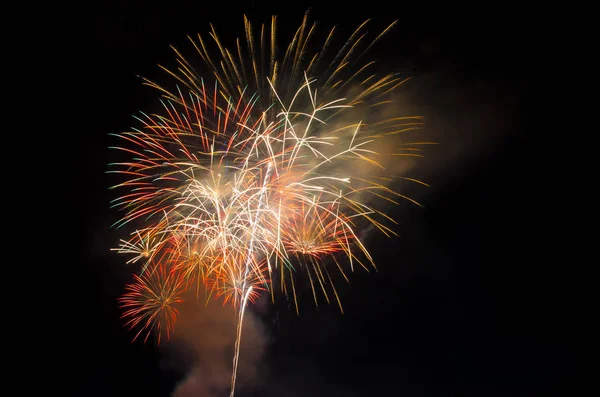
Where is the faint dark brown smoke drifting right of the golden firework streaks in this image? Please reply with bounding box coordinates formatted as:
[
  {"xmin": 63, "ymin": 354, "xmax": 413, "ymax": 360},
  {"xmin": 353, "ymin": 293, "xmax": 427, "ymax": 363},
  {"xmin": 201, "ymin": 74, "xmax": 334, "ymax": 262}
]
[{"xmin": 396, "ymin": 70, "xmax": 518, "ymax": 187}]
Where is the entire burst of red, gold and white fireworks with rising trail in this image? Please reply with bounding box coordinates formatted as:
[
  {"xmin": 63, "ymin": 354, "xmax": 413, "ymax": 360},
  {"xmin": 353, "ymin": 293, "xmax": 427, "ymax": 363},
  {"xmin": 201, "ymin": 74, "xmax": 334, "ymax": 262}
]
[{"xmin": 109, "ymin": 15, "xmax": 429, "ymax": 397}]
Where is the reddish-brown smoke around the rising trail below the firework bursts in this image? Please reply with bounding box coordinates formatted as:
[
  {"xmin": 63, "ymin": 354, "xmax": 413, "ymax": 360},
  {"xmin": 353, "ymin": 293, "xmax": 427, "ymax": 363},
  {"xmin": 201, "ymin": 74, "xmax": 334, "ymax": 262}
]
[{"xmin": 164, "ymin": 289, "xmax": 268, "ymax": 397}]
